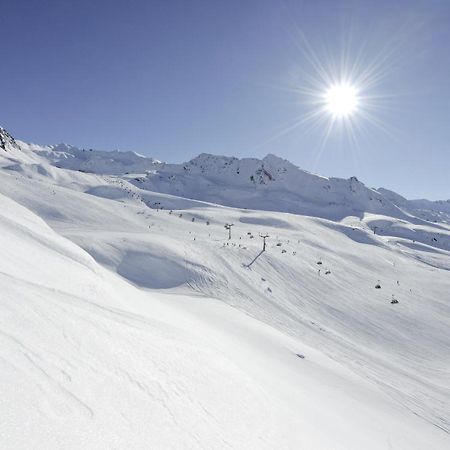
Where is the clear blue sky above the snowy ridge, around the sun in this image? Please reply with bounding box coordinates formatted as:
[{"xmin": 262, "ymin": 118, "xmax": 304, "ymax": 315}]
[{"xmin": 0, "ymin": 0, "xmax": 450, "ymax": 199}]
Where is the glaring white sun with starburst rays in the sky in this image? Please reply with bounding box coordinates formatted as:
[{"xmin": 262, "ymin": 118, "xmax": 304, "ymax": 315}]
[{"xmin": 270, "ymin": 31, "xmax": 396, "ymax": 149}]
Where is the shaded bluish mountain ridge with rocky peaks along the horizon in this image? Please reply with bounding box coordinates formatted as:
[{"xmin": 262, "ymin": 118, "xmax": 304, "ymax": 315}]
[{"xmin": 10, "ymin": 127, "xmax": 450, "ymax": 224}]
